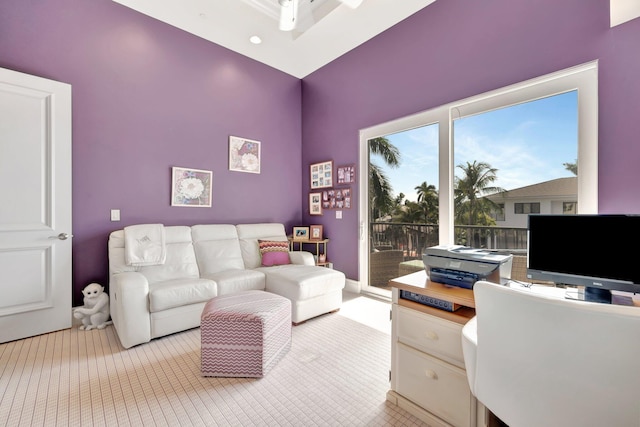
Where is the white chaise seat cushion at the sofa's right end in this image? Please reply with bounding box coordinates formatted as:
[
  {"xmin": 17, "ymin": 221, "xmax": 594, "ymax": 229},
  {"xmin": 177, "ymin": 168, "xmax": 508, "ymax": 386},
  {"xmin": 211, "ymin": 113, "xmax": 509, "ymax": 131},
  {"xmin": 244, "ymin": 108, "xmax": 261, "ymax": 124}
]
[{"xmin": 256, "ymin": 264, "xmax": 346, "ymax": 301}]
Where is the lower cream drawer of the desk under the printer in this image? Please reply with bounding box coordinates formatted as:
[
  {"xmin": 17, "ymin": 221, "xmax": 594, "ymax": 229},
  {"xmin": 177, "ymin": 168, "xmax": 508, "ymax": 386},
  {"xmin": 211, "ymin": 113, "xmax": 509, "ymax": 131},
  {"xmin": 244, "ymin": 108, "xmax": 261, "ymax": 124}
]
[{"xmin": 396, "ymin": 343, "xmax": 475, "ymax": 427}]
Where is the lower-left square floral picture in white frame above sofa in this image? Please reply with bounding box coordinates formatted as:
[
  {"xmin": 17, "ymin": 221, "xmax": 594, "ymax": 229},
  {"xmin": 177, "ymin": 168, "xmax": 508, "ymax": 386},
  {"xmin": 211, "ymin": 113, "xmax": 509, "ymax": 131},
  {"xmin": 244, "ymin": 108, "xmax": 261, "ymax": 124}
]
[{"xmin": 171, "ymin": 166, "xmax": 213, "ymax": 208}]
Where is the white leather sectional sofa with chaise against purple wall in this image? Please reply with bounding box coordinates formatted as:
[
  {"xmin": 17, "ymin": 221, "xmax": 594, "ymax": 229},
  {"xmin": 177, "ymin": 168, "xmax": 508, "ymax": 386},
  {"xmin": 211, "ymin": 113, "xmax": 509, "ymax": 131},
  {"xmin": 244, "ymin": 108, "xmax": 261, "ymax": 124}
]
[{"xmin": 108, "ymin": 223, "xmax": 346, "ymax": 348}]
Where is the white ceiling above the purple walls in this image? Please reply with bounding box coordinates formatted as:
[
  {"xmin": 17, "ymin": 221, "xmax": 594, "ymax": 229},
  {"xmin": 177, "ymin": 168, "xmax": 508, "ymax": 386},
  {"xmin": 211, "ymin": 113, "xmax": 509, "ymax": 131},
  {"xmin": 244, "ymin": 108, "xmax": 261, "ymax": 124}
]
[{"xmin": 113, "ymin": 0, "xmax": 435, "ymax": 78}]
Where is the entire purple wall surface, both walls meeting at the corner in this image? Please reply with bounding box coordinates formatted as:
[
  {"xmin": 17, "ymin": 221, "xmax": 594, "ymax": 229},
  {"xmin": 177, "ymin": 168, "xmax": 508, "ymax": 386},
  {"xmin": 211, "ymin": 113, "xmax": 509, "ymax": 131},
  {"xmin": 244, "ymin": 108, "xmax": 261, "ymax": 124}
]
[{"xmin": 0, "ymin": 0, "xmax": 640, "ymax": 305}]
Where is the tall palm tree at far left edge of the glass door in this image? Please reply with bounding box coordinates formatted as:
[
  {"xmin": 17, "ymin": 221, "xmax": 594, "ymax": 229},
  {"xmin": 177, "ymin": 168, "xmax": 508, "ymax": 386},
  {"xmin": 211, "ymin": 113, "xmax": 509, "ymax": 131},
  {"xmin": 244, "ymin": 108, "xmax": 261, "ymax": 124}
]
[{"xmin": 369, "ymin": 137, "xmax": 400, "ymax": 219}]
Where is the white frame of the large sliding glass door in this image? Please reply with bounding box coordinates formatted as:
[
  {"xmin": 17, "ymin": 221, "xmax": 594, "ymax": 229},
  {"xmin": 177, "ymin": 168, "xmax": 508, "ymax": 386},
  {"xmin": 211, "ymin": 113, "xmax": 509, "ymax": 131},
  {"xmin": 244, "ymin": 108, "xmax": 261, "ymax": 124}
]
[{"xmin": 359, "ymin": 61, "xmax": 598, "ymax": 288}]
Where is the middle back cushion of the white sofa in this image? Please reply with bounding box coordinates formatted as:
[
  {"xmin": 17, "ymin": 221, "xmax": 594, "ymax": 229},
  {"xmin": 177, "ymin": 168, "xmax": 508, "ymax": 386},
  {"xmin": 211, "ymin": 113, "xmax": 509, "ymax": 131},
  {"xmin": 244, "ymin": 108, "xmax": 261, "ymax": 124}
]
[{"xmin": 191, "ymin": 224, "xmax": 244, "ymax": 277}]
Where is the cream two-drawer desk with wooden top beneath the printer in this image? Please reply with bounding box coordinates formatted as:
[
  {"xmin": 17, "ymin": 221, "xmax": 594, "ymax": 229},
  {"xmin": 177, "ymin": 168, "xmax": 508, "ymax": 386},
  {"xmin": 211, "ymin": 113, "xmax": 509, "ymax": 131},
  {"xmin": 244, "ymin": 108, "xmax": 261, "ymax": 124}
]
[{"xmin": 387, "ymin": 270, "xmax": 488, "ymax": 427}]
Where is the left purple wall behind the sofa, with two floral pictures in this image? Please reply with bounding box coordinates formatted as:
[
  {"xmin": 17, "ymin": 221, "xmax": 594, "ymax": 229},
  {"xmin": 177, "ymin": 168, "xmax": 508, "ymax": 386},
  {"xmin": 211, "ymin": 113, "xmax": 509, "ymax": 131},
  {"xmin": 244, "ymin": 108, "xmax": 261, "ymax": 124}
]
[{"xmin": 0, "ymin": 0, "xmax": 302, "ymax": 305}]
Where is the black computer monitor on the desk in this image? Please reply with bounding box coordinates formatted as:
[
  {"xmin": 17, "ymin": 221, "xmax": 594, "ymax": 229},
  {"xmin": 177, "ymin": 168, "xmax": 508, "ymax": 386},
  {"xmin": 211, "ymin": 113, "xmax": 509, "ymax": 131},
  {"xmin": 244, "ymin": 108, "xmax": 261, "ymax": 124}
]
[{"xmin": 527, "ymin": 214, "xmax": 640, "ymax": 302}]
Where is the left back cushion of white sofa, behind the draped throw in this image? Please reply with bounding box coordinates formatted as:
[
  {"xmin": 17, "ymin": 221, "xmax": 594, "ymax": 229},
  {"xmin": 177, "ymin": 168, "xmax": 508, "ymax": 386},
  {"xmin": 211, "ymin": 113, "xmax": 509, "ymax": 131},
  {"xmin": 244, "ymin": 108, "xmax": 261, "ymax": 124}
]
[{"xmin": 109, "ymin": 226, "xmax": 200, "ymax": 283}]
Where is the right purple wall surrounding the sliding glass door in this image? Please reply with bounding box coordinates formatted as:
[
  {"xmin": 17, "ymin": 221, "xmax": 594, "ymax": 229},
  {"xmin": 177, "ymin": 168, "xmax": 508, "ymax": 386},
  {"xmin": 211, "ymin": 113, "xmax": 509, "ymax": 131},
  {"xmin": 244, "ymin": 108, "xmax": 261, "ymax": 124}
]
[{"xmin": 302, "ymin": 0, "xmax": 640, "ymax": 279}]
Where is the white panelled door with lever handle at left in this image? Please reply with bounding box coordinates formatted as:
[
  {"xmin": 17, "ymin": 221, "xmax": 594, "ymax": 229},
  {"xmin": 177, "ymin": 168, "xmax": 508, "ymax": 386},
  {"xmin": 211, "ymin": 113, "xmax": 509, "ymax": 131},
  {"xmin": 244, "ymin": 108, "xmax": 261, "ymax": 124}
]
[{"xmin": 0, "ymin": 68, "xmax": 72, "ymax": 342}]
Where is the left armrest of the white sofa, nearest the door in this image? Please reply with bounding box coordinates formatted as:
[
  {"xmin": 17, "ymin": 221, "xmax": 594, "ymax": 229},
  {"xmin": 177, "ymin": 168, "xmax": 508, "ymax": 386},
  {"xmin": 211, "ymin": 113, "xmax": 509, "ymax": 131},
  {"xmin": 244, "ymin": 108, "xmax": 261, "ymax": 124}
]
[{"xmin": 109, "ymin": 272, "xmax": 151, "ymax": 348}]
